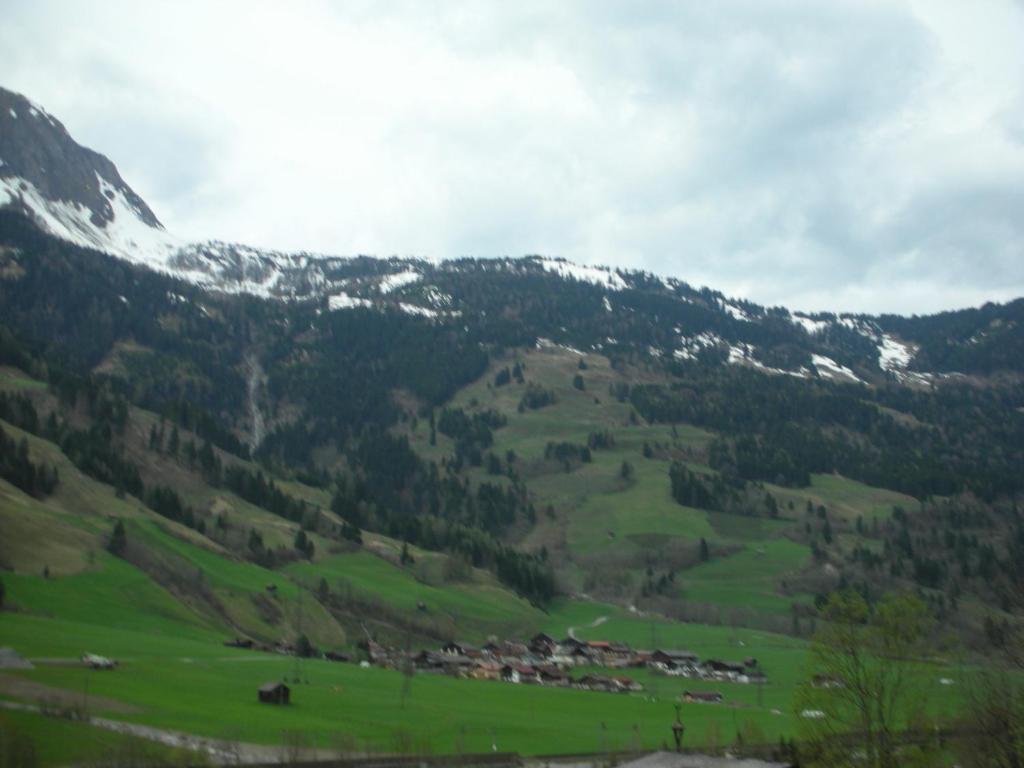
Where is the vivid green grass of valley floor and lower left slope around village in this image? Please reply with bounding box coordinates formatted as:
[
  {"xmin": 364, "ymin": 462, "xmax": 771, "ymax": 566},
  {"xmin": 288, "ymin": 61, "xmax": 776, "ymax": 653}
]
[{"xmin": 0, "ymin": 493, "xmax": 966, "ymax": 760}]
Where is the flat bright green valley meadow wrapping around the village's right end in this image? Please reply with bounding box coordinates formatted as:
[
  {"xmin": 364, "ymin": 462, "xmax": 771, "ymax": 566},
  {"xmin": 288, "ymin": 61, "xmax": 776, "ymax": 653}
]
[{"xmin": 0, "ymin": 589, "xmax": 957, "ymax": 765}]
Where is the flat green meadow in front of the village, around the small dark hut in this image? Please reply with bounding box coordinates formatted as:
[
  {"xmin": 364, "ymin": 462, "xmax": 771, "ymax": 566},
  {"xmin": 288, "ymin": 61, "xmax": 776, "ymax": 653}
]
[{"xmin": 3, "ymin": 614, "xmax": 791, "ymax": 754}]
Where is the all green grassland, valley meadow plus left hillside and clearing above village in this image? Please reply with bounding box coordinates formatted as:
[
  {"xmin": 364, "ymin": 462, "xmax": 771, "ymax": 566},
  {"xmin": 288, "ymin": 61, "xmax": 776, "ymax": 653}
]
[{"xmin": 0, "ymin": 356, "xmax": 974, "ymax": 764}]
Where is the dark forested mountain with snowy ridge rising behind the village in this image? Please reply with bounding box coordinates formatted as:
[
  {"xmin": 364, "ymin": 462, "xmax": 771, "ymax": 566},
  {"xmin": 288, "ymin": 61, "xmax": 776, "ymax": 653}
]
[{"xmin": 0, "ymin": 85, "xmax": 1024, "ymax": 643}]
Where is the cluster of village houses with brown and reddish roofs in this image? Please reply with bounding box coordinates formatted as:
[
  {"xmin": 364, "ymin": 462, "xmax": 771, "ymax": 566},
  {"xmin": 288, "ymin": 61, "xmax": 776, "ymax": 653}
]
[{"xmin": 365, "ymin": 633, "xmax": 767, "ymax": 700}]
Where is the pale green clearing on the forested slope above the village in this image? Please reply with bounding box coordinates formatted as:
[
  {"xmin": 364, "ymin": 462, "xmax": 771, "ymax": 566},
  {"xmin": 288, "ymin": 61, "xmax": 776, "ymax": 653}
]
[{"xmin": 410, "ymin": 346, "xmax": 868, "ymax": 630}]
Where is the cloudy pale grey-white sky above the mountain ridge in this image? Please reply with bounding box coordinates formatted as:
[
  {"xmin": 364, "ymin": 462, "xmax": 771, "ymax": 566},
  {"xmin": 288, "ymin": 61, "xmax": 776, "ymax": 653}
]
[{"xmin": 0, "ymin": 0, "xmax": 1024, "ymax": 314}]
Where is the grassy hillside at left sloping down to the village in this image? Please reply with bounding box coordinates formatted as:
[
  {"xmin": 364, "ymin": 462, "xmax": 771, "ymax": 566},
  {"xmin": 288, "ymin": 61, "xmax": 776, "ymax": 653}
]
[{"xmin": 0, "ymin": 369, "xmax": 541, "ymax": 648}]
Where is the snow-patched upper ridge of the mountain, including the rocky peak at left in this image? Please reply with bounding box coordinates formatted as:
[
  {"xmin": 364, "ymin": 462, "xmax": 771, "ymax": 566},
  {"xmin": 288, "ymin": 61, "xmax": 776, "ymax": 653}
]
[{"xmin": 6, "ymin": 88, "xmax": 1016, "ymax": 386}]
